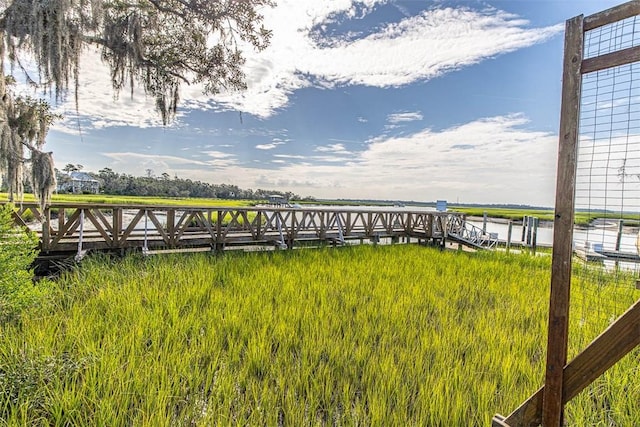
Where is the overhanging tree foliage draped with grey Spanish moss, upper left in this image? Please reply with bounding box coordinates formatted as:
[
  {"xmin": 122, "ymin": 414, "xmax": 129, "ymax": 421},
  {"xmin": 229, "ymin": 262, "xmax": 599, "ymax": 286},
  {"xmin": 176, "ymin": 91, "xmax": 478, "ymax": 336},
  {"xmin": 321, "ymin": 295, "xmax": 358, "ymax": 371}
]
[{"xmin": 0, "ymin": 0, "xmax": 272, "ymax": 207}]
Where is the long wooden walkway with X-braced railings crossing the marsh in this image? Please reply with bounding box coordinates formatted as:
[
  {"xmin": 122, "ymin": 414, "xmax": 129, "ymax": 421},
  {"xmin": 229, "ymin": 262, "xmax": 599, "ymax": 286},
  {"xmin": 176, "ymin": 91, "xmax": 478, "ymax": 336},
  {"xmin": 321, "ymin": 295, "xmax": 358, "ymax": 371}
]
[{"xmin": 3, "ymin": 203, "xmax": 462, "ymax": 270}]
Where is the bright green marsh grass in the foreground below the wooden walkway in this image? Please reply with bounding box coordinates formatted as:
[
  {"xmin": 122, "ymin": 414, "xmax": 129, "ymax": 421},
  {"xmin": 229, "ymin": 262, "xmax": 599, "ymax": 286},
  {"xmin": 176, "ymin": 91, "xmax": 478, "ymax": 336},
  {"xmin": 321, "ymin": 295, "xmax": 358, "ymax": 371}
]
[{"xmin": 0, "ymin": 245, "xmax": 640, "ymax": 426}]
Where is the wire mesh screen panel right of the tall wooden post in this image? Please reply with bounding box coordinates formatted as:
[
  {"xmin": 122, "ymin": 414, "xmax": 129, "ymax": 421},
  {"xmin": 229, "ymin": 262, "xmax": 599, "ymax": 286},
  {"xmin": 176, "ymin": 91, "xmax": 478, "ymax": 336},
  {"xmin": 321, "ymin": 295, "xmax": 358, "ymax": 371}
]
[{"xmin": 572, "ymin": 17, "xmax": 640, "ymax": 352}]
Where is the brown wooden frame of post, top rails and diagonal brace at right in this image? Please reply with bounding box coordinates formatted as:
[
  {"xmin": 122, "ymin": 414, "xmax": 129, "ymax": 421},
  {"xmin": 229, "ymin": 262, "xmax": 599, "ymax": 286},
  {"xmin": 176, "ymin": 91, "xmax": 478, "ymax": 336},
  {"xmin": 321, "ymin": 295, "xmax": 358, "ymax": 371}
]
[{"xmin": 492, "ymin": 0, "xmax": 640, "ymax": 427}]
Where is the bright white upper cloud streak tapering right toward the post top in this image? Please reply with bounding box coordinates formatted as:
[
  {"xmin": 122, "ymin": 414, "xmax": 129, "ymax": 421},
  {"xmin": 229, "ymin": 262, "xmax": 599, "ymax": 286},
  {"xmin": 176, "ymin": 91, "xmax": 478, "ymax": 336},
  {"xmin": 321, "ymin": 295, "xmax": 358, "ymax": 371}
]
[{"xmin": 210, "ymin": 0, "xmax": 563, "ymax": 117}]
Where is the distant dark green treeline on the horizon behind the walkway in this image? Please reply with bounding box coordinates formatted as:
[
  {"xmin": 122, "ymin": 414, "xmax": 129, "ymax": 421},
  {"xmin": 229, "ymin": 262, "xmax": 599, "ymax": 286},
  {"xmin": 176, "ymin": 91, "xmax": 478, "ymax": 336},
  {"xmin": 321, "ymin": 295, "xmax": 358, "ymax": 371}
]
[{"xmin": 57, "ymin": 168, "xmax": 310, "ymax": 200}]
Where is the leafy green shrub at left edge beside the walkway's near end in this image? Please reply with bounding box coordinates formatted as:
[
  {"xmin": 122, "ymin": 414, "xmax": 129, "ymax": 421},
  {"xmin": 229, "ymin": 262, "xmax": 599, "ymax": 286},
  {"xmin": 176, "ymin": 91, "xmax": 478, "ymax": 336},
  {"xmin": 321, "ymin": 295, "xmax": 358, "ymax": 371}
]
[{"xmin": 0, "ymin": 204, "xmax": 45, "ymax": 324}]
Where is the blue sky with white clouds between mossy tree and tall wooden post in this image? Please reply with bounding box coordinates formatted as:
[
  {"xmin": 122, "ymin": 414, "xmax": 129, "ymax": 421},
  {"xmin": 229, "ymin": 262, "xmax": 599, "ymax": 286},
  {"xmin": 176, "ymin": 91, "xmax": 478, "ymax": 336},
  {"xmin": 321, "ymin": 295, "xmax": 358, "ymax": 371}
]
[{"xmin": 23, "ymin": 0, "xmax": 620, "ymax": 206}]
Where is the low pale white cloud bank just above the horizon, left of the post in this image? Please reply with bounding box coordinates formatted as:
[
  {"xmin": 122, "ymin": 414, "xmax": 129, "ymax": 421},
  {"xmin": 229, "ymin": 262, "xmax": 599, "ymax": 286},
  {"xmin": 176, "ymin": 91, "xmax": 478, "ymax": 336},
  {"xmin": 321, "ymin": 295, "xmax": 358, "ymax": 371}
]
[{"xmin": 138, "ymin": 115, "xmax": 558, "ymax": 206}]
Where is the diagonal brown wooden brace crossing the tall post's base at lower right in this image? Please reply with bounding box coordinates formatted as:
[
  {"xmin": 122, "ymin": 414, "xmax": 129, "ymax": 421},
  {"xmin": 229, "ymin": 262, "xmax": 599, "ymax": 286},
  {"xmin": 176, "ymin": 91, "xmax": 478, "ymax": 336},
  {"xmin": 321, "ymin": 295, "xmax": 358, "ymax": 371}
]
[{"xmin": 502, "ymin": 300, "xmax": 640, "ymax": 427}]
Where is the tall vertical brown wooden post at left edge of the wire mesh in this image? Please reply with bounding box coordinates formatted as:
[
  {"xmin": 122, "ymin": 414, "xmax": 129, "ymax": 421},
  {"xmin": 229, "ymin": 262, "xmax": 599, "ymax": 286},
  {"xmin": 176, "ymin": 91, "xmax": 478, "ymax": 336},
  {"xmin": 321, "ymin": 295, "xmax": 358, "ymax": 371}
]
[{"xmin": 542, "ymin": 15, "xmax": 584, "ymax": 427}]
